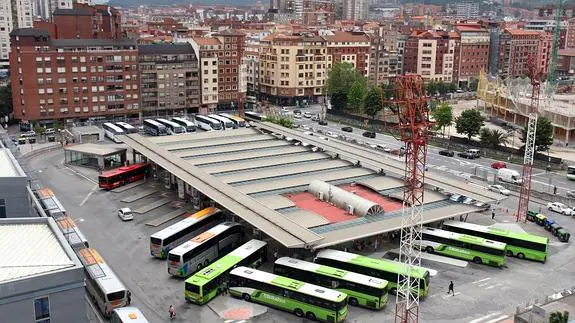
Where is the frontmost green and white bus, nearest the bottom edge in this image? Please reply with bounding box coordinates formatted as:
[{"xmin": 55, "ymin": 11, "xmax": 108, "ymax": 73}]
[{"xmin": 229, "ymin": 267, "xmax": 347, "ymax": 322}]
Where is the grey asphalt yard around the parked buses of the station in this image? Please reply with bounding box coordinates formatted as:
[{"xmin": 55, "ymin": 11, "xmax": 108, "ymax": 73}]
[{"xmin": 30, "ymin": 151, "xmax": 575, "ymax": 323}]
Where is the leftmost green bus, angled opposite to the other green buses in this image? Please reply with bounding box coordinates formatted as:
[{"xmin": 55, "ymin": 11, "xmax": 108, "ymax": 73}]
[{"xmin": 185, "ymin": 239, "xmax": 267, "ymax": 305}]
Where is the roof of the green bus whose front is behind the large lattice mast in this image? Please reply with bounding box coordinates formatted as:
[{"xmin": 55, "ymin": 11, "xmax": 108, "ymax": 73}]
[{"xmin": 317, "ymin": 249, "xmax": 429, "ymax": 278}]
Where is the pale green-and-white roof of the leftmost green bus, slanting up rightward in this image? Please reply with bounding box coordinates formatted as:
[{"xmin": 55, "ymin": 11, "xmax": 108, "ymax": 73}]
[{"xmin": 186, "ymin": 239, "xmax": 267, "ymax": 286}]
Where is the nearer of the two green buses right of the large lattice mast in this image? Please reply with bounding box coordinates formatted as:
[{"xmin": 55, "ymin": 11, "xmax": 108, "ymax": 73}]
[{"xmin": 421, "ymin": 228, "xmax": 506, "ymax": 267}]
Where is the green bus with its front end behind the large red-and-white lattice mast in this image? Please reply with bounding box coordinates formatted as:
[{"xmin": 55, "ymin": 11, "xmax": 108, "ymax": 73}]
[{"xmin": 314, "ymin": 249, "xmax": 429, "ymax": 296}]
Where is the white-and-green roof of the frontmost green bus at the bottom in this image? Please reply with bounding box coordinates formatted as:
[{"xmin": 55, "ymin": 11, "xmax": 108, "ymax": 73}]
[{"xmin": 230, "ymin": 267, "xmax": 347, "ymax": 302}]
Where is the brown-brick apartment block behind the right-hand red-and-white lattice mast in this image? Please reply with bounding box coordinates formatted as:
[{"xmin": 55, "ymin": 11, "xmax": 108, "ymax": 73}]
[{"xmin": 497, "ymin": 28, "xmax": 553, "ymax": 77}]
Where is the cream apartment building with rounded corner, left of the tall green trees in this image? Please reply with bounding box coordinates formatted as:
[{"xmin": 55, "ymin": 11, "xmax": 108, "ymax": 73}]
[{"xmin": 259, "ymin": 33, "xmax": 328, "ymax": 105}]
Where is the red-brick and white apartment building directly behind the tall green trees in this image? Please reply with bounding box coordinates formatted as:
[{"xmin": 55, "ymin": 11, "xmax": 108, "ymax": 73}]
[{"xmin": 323, "ymin": 31, "xmax": 371, "ymax": 76}]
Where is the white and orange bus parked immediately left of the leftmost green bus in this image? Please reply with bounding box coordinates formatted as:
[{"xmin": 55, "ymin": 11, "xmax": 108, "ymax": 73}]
[{"xmin": 168, "ymin": 222, "xmax": 242, "ymax": 277}]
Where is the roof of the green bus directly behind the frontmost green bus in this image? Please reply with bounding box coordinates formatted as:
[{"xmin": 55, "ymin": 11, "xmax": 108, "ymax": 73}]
[{"xmin": 275, "ymin": 257, "xmax": 387, "ymax": 289}]
